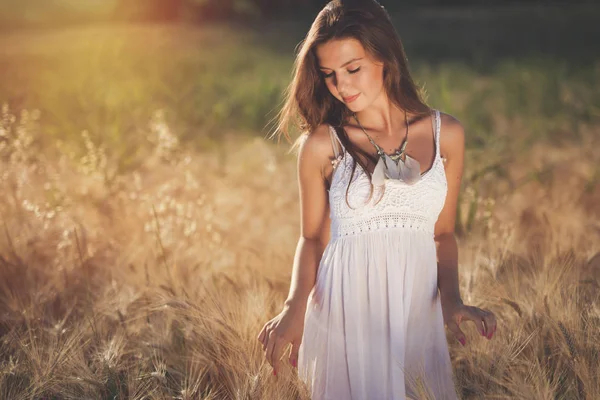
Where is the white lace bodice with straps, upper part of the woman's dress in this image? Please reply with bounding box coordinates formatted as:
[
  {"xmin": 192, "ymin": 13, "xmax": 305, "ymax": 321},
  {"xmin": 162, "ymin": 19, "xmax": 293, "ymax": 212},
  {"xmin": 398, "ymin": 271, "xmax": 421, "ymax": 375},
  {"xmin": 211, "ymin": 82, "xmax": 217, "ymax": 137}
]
[{"xmin": 329, "ymin": 110, "xmax": 448, "ymax": 239}]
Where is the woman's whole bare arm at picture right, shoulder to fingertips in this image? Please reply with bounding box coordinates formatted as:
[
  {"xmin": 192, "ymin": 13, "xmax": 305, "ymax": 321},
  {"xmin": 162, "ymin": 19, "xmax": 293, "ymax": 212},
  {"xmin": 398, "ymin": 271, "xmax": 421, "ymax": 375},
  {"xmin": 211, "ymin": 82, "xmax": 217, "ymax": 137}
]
[{"xmin": 434, "ymin": 114, "xmax": 496, "ymax": 345}]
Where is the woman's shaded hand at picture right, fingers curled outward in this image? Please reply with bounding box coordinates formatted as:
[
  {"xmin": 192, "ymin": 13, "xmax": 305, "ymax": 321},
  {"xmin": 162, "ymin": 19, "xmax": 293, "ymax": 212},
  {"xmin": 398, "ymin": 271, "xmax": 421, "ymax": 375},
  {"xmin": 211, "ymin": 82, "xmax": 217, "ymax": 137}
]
[{"xmin": 442, "ymin": 300, "xmax": 496, "ymax": 346}]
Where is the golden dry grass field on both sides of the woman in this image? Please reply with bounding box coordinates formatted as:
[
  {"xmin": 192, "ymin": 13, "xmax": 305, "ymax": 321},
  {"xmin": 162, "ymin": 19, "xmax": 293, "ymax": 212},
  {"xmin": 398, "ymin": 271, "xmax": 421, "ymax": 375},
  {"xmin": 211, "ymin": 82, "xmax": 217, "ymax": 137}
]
[{"xmin": 0, "ymin": 101, "xmax": 600, "ymax": 399}]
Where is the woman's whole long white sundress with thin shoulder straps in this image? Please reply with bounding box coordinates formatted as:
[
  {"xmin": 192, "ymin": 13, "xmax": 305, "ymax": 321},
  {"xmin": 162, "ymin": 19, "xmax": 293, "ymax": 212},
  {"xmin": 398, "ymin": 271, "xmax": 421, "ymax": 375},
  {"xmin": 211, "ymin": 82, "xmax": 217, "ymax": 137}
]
[{"xmin": 298, "ymin": 110, "xmax": 457, "ymax": 400}]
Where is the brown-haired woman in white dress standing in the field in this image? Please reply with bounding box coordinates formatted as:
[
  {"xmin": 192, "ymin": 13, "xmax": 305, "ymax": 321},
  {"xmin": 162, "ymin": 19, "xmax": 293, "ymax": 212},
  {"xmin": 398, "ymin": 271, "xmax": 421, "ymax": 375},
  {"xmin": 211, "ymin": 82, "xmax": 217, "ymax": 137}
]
[{"xmin": 258, "ymin": 0, "xmax": 496, "ymax": 400}]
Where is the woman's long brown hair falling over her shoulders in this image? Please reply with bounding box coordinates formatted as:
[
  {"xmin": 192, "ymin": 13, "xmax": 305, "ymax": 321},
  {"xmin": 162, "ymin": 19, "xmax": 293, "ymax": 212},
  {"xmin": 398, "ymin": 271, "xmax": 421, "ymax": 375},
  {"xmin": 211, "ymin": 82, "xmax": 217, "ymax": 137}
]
[{"xmin": 272, "ymin": 0, "xmax": 431, "ymax": 203}]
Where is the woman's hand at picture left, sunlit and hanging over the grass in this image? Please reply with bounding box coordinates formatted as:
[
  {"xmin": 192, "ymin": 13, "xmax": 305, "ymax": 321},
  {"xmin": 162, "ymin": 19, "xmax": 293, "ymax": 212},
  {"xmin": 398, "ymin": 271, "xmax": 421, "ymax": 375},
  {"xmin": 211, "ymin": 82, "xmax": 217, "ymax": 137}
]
[{"xmin": 258, "ymin": 307, "xmax": 304, "ymax": 375}]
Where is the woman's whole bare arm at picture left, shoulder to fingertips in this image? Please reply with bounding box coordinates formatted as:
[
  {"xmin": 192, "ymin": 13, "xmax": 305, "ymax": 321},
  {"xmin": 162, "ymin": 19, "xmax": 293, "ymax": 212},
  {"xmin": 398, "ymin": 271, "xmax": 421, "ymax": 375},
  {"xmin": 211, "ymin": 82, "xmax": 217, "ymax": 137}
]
[{"xmin": 258, "ymin": 125, "xmax": 333, "ymax": 373}]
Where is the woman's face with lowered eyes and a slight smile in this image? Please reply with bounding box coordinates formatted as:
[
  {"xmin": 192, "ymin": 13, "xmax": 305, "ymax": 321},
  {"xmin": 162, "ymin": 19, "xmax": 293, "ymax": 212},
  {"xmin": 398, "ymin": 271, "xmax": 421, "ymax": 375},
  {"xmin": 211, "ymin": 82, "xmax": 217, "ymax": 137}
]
[{"xmin": 316, "ymin": 38, "xmax": 385, "ymax": 112}]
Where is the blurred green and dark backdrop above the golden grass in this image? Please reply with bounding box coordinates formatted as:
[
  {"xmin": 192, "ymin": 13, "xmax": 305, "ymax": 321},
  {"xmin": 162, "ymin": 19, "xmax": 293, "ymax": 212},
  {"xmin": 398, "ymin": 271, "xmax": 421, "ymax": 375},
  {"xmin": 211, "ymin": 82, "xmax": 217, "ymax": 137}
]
[{"xmin": 0, "ymin": 0, "xmax": 600, "ymax": 154}]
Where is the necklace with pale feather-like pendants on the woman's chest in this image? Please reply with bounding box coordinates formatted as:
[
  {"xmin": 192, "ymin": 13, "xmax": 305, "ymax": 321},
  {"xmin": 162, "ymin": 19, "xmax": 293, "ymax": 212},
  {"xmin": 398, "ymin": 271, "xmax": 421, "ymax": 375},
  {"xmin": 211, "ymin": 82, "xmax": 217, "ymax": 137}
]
[{"xmin": 352, "ymin": 111, "xmax": 421, "ymax": 186}]
